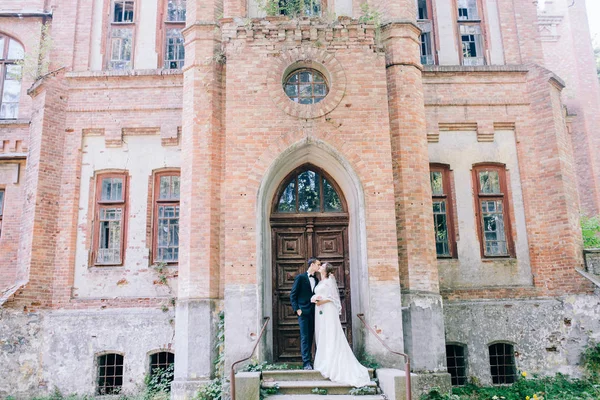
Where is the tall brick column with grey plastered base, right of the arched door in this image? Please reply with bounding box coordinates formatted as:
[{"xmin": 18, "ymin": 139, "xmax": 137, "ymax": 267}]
[{"xmin": 382, "ymin": 18, "xmax": 445, "ymax": 371}]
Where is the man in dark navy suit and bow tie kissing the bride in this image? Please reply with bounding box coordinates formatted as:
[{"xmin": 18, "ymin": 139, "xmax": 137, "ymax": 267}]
[{"xmin": 290, "ymin": 258, "xmax": 321, "ymax": 370}]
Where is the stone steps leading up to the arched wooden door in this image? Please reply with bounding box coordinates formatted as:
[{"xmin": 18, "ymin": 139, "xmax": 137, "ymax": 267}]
[{"xmin": 261, "ymin": 369, "xmax": 385, "ymax": 400}]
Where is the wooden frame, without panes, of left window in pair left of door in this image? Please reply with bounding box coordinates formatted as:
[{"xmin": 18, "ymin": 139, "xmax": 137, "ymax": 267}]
[{"xmin": 90, "ymin": 171, "xmax": 129, "ymax": 267}]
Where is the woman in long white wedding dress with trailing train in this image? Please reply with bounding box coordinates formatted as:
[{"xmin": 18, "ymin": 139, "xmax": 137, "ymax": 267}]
[{"xmin": 311, "ymin": 263, "xmax": 371, "ymax": 387}]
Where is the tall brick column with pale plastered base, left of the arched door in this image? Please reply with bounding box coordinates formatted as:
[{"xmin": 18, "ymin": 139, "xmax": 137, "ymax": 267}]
[{"xmin": 173, "ymin": 0, "xmax": 223, "ymax": 399}]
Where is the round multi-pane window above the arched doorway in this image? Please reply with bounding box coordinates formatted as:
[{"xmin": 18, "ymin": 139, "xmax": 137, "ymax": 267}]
[{"xmin": 283, "ymin": 69, "xmax": 329, "ymax": 104}]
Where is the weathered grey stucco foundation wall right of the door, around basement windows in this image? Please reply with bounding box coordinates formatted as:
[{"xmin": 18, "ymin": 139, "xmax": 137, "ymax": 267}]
[{"xmin": 444, "ymin": 295, "xmax": 600, "ymax": 384}]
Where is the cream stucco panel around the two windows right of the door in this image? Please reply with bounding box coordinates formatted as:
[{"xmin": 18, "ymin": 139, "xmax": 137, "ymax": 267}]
[{"xmin": 429, "ymin": 130, "xmax": 532, "ymax": 289}]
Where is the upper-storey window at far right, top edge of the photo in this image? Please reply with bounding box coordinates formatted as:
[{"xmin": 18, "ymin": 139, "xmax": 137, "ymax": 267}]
[{"xmin": 456, "ymin": 0, "xmax": 485, "ymax": 66}]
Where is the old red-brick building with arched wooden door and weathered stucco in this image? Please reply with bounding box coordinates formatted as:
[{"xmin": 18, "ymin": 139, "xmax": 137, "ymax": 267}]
[{"xmin": 0, "ymin": 0, "xmax": 600, "ymax": 398}]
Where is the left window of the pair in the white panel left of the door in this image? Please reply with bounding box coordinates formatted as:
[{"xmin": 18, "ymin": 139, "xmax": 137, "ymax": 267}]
[{"xmin": 94, "ymin": 174, "xmax": 127, "ymax": 265}]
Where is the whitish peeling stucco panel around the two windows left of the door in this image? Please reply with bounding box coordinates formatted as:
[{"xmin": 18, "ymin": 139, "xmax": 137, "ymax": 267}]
[{"xmin": 73, "ymin": 135, "xmax": 181, "ymax": 298}]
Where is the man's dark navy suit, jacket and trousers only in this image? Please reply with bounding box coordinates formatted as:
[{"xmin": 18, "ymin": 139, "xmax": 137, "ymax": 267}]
[{"xmin": 290, "ymin": 273, "xmax": 318, "ymax": 366}]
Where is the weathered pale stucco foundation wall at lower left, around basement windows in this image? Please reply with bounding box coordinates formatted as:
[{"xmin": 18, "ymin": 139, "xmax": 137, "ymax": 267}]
[{"xmin": 0, "ymin": 309, "xmax": 175, "ymax": 398}]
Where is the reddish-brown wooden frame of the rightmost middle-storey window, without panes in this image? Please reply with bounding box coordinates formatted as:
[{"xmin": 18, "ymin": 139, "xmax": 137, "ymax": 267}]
[{"xmin": 472, "ymin": 163, "xmax": 516, "ymax": 260}]
